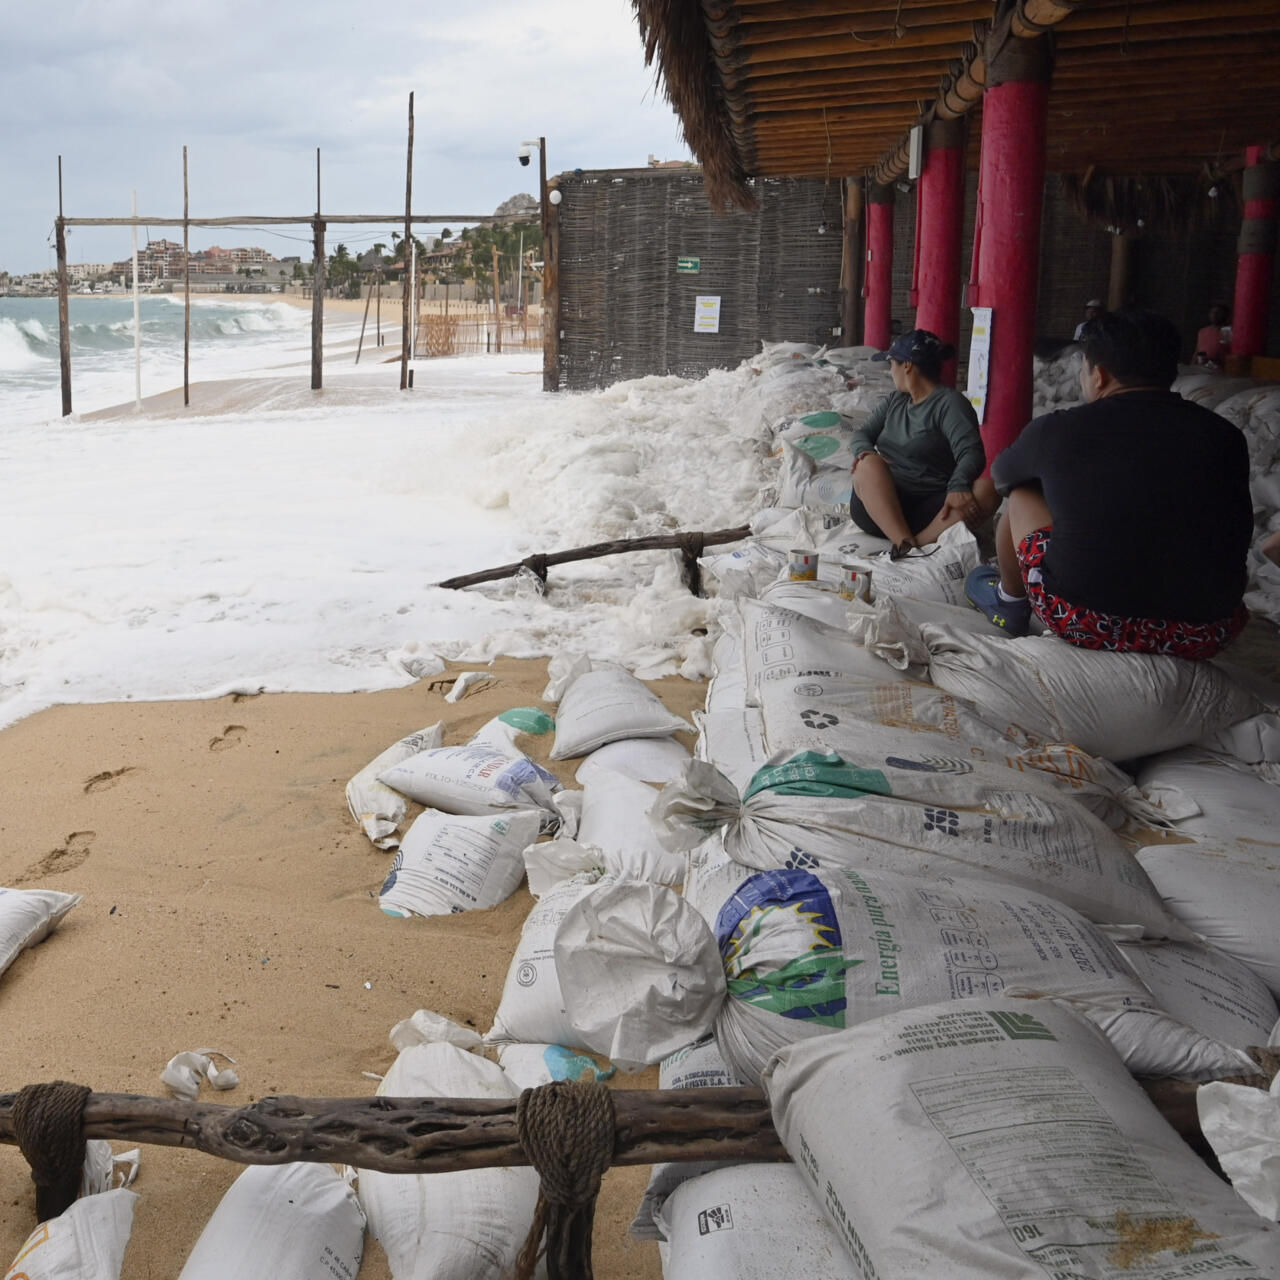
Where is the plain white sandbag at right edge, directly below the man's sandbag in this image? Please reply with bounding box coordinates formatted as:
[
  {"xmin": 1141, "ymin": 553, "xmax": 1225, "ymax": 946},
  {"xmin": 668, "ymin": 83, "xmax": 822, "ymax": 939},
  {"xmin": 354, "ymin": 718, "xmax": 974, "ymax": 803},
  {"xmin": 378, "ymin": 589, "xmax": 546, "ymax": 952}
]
[{"xmin": 1137, "ymin": 746, "xmax": 1280, "ymax": 851}]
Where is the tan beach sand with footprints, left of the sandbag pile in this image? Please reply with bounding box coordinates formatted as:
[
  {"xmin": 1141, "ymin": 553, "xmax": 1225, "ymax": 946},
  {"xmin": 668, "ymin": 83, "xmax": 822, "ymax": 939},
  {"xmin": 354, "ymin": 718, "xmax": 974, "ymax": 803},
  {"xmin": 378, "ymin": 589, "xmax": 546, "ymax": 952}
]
[{"xmin": 0, "ymin": 659, "xmax": 704, "ymax": 1280}]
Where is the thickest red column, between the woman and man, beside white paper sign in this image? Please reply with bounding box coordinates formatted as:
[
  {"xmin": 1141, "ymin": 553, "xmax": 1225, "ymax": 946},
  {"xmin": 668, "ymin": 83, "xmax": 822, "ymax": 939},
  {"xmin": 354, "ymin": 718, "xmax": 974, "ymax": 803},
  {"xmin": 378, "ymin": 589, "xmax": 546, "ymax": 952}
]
[{"xmin": 972, "ymin": 36, "xmax": 1053, "ymax": 463}]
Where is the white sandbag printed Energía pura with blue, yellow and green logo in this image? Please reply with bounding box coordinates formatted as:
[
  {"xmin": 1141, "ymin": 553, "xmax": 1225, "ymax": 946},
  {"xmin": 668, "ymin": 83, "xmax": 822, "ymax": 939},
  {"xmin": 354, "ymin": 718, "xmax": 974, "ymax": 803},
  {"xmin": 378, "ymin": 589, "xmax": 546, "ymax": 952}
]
[{"xmin": 716, "ymin": 870, "xmax": 1252, "ymax": 1082}]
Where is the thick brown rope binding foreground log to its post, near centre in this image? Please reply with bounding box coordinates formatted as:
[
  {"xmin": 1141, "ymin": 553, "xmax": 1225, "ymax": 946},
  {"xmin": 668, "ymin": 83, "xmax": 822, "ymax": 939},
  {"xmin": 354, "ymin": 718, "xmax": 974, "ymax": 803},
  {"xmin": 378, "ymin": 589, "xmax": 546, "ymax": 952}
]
[{"xmin": 516, "ymin": 1080, "xmax": 614, "ymax": 1280}]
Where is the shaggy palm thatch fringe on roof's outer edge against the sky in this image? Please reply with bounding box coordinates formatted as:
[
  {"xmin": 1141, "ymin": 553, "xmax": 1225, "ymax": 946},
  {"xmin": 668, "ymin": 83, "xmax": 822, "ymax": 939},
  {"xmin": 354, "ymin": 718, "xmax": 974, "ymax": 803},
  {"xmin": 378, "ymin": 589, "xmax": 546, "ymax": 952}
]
[{"xmin": 632, "ymin": 0, "xmax": 756, "ymax": 210}]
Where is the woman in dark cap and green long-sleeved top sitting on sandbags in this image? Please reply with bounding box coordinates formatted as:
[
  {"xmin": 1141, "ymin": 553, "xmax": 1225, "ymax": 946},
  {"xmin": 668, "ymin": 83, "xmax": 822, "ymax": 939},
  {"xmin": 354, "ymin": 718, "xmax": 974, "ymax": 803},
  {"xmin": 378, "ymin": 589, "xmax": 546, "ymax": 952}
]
[{"xmin": 849, "ymin": 329, "xmax": 996, "ymax": 559}]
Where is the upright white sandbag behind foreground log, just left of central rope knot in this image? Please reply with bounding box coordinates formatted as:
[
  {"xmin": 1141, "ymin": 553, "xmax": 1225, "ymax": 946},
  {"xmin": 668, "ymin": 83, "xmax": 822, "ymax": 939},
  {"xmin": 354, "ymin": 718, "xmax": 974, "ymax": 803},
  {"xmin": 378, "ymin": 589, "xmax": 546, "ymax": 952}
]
[{"xmin": 358, "ymin": 1044, "xmax": 538, "ymax": 1280}]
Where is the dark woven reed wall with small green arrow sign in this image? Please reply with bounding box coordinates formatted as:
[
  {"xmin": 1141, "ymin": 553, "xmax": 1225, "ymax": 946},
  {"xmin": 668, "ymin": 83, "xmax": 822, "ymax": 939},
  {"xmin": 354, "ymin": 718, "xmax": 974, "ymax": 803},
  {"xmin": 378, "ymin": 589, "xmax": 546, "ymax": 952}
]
[{"xmin": 558, "ymin": 169, "xmax": 841, "ymax": 390}]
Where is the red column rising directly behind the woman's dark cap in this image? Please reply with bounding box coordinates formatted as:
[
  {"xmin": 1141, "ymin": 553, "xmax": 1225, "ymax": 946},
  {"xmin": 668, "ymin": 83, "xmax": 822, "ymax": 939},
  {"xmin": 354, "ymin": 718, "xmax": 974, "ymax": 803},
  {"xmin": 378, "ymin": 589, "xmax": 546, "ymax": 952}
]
[{"xmin": 915, "ymin": 120, "xmax": 964, "ymax": 387}]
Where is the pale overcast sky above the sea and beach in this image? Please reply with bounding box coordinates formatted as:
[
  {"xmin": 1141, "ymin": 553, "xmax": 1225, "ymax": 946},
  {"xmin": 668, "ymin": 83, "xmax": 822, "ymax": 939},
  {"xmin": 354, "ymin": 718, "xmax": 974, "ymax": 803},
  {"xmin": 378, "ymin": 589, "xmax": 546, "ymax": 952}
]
[{"xmin": 0, "ymin": 0, "xmax": 689, "ymax": 273}]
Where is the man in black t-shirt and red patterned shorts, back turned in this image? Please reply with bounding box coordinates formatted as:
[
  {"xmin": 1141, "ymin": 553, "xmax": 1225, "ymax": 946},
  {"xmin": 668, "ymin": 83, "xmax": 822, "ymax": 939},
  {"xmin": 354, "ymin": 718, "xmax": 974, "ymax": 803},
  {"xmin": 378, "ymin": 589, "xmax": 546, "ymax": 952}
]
[{"xmin": 965, "ymin": 310, "xmax": 1253, "ymax": 658}]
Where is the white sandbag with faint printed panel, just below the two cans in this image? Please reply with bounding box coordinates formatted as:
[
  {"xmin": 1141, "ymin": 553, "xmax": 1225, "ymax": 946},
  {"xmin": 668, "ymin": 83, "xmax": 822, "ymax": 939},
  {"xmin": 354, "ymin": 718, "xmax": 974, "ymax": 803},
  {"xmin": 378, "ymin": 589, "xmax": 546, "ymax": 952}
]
[{"xmin": 739, "ymin": 600, "xmax": 893, "ymax": 707}]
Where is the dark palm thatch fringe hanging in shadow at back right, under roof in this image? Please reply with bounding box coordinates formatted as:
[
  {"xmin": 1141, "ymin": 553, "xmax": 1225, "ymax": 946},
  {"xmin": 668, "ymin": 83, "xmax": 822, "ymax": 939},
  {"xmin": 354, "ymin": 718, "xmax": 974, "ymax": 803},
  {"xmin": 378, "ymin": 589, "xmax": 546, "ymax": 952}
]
[{"xmin": 1062, "ymin": 166, "xmax": 1239, "ymax": 237}]
